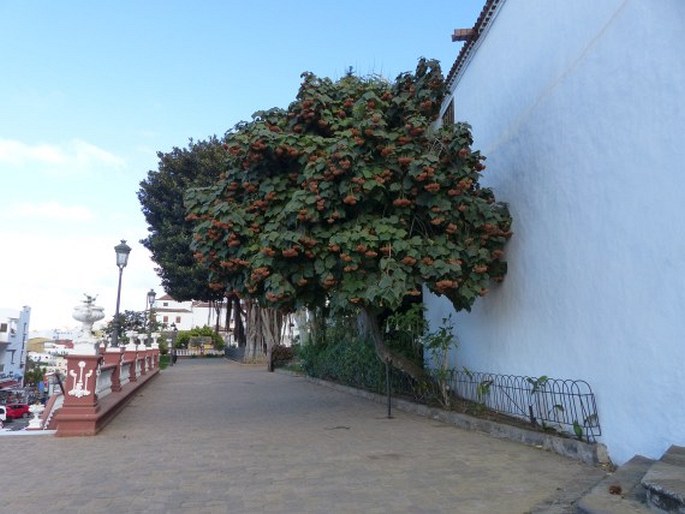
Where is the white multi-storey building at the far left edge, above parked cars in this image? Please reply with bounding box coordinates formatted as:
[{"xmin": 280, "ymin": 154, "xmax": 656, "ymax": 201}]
[{"xmin": 0, "ymin": 306, "xmax": 31, "ymax": 389}]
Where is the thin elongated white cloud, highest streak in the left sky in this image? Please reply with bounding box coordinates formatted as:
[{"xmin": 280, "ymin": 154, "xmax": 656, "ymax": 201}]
[{"xmin": 0, "ymin": 139, "xmax": 125, "ymax": 177}]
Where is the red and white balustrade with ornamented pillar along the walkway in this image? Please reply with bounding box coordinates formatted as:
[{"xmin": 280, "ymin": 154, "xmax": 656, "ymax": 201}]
[{"xmin": 39, "ymin": 343, "xmax": 159, "ymax": 436}]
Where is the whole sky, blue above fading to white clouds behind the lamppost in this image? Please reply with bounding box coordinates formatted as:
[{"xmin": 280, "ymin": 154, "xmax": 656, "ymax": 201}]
[{"xmin": 0, "ymin": 0, "xmax": 485, "ymax": 330}]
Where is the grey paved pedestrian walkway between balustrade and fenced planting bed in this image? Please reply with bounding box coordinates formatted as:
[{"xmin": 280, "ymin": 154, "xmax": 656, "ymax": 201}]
[{"xmin": 0, "ymin": 359, "xmax": 603, "ymax": 514}]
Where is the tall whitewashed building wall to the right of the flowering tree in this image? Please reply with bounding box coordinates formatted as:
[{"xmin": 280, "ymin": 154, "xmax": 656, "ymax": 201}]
[{"xmin": 427, "ymin": 0, "xmax": 685, "ymax": 464}]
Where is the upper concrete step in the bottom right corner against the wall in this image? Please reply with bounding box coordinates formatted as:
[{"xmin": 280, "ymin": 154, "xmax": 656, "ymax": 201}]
[{"xmin": 642, "ymin": 446, "xmax": 685, "ymax": 514}]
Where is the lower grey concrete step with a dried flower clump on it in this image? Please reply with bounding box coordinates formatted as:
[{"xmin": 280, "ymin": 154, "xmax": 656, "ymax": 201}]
[{"xmin": 575, "ymin": 455, "xmax": 655, "ymax": 514}]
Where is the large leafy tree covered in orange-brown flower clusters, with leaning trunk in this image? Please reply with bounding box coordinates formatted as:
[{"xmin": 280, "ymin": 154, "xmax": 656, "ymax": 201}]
[{"xmin": 185, "ymin": 59, "xmax": 511, "ymax": 375}]
